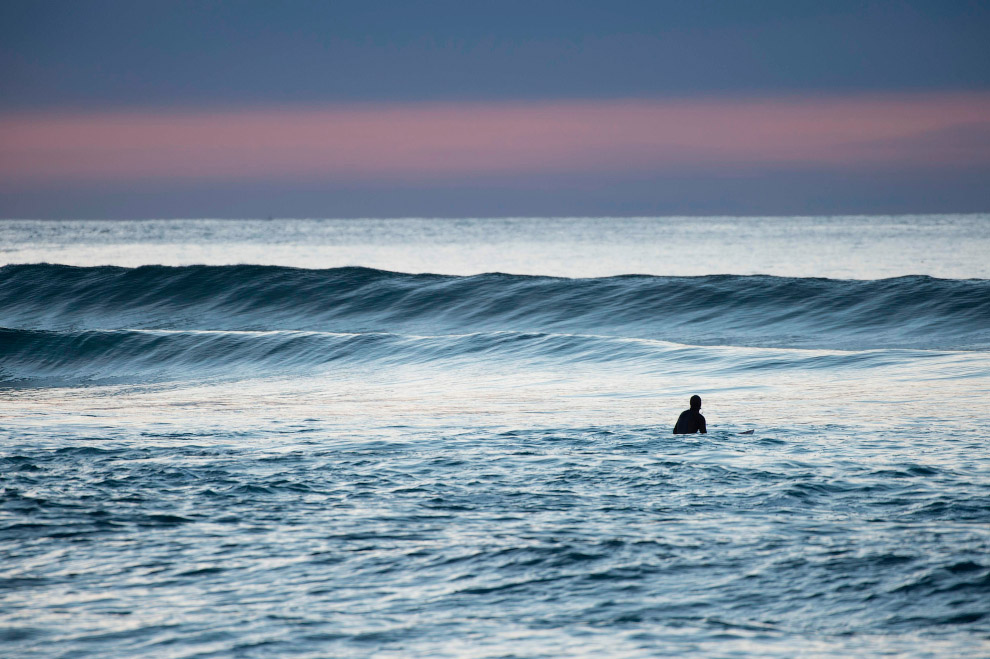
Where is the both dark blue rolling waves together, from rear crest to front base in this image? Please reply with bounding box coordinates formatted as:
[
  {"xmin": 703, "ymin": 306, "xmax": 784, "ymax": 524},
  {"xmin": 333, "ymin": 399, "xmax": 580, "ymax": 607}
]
[{"xmin": 0, "ymin": 264, "xmax": 990, "ymax": 384}]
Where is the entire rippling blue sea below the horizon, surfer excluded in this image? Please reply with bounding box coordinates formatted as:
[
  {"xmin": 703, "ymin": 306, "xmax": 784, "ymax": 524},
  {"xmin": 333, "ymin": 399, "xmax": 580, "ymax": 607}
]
[{"xmin": 0, "ymin": 215, "xmax": 990, "ymax": 657}]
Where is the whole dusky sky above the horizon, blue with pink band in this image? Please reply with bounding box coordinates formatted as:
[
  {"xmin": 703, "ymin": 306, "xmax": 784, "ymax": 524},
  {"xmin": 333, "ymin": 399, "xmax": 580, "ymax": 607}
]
[{"xmin": 0, "ymin": 0, "xmax": 990, "ymax": 218}]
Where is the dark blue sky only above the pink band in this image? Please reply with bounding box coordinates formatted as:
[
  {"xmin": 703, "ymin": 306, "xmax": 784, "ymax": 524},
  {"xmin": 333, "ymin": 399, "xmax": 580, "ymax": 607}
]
[{"xmin": 0, "ymin": 0, "xmax": 990, "ymax": 109}]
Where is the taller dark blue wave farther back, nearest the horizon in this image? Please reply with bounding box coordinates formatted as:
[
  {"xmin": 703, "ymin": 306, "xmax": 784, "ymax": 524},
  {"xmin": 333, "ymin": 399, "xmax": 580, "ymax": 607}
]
[{"xmin": 0, "ymin": 264, "xmax": 990, "ymax": 349}]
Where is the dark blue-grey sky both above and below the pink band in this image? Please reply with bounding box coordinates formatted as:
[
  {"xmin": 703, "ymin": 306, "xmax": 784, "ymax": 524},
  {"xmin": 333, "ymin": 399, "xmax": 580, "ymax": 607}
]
[{"xmin": 0, "ymin": 0, "xmax": 990, "ymax": 217}]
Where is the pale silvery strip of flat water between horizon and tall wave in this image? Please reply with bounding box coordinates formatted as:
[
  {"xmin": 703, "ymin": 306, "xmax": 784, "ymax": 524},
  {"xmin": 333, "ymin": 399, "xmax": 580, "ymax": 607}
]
[{"xmin": 0, "ymin": 214, "xmax": 990, "ymax": 279}]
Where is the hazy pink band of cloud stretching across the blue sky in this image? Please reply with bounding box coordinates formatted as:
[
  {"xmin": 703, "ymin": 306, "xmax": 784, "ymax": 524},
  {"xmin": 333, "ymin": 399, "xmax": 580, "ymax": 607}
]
[{"xmin": 0, "ymin": 93, "xmax": 990, "ymax": 185}]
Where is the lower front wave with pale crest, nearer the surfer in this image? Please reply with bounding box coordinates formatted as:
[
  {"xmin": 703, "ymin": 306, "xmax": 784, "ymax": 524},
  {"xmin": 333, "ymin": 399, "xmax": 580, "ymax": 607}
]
[{"xmin": 0, "ymin": 328, "xmax": 988, "ymax": 386}]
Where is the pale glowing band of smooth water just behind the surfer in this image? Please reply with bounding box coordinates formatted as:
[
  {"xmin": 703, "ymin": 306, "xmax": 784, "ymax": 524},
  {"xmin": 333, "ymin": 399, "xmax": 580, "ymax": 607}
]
[{"xmin": 6, "ymin": 340, "xmax": 990, "ymax": 448}]
